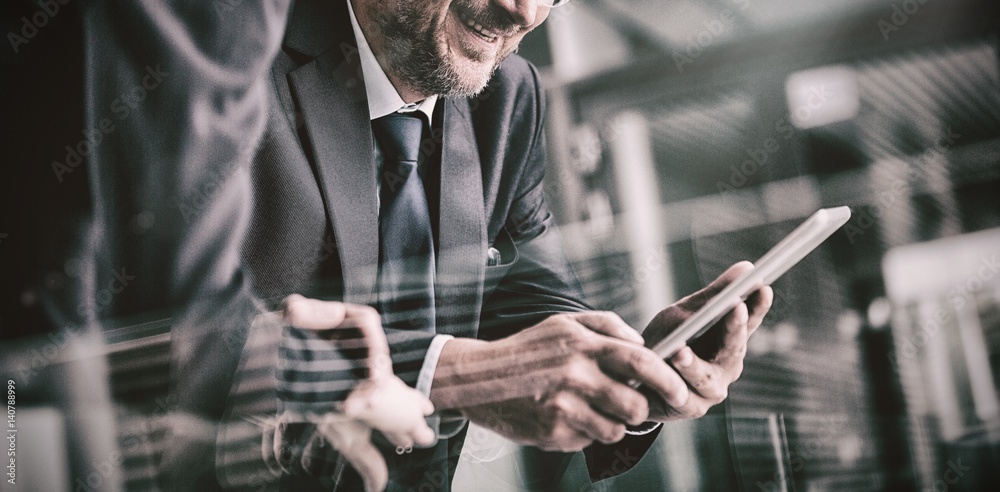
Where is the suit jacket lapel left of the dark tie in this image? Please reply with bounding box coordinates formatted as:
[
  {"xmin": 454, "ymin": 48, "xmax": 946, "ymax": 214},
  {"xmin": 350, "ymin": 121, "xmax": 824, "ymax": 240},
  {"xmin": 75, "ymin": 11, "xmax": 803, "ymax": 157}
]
[{"xmin": 289, "ymin": 40, "xmax": 379, "ymax": 304}]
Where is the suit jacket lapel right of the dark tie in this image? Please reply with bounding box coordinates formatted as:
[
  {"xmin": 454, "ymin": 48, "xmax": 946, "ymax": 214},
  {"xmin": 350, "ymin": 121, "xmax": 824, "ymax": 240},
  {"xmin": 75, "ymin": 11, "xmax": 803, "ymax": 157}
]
[{"xmin": 434, "ymin": 98, "xmax": 486, "ymax": 337}]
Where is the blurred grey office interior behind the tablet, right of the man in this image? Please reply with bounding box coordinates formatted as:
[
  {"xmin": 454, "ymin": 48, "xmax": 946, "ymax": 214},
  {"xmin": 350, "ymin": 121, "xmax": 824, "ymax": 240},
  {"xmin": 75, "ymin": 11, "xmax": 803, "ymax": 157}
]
[{"xmin": 456, "ymin": 0, "xmax": 1000, "ymax": 491}]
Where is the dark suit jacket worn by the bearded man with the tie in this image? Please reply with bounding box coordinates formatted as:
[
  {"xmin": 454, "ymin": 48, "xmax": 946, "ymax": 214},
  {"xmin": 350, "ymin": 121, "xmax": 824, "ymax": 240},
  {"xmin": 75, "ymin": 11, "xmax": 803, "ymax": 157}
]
[{"xmin": 235, "ymin": 1, "xmax": 656, "ymax": 487}]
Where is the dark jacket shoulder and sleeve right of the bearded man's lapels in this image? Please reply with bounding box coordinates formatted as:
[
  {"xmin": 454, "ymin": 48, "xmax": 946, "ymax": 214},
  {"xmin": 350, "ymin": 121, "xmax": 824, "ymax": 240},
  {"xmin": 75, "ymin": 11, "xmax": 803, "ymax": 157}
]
[{"xmin": 477, "ymin": 57, "xmax": 590, "ymax": 340}]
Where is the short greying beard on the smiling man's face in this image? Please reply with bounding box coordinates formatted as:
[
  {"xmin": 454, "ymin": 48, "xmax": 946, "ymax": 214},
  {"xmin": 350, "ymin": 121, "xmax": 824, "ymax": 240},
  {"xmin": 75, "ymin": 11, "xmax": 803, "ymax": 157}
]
[{"xmin": 373, "ymin": 0, "xmax": 518, "ymax": 97}]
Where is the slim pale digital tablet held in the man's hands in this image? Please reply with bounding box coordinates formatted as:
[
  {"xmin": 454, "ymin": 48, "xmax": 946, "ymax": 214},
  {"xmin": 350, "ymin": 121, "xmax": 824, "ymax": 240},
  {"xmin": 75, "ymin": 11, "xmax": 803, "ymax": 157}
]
[{"xmin": 653, "ymin": 207, "xmax": 851, "ymax": 359}]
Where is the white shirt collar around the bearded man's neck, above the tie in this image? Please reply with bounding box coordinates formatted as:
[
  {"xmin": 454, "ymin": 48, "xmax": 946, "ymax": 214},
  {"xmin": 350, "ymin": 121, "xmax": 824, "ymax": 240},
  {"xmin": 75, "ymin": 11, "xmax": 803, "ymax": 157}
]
[{"xmin": 345, "ymin": 0, "xmax": 437, "ymax": 122}]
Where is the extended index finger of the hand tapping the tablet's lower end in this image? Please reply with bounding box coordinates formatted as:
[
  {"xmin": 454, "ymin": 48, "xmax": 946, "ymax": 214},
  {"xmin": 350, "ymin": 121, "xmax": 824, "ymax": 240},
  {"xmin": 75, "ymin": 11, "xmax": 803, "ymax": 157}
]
[{"xmin": 597, "ymin": 340, "xmax": 689, "ymax": 407}]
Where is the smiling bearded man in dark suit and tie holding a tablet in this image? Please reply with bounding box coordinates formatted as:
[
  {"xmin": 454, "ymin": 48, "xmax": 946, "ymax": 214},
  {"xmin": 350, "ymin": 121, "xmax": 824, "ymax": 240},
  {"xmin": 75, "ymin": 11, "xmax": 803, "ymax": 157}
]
[{"xmin": 244, "ymin": 0, "xmax": 771, "ymax": 489}]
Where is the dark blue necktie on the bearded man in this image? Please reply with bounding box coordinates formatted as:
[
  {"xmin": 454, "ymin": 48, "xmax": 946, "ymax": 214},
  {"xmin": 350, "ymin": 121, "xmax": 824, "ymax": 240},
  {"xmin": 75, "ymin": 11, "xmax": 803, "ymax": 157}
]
[{"xmin": 372, "ymin": 113, "xmax": 434, "ymax": 332}]
